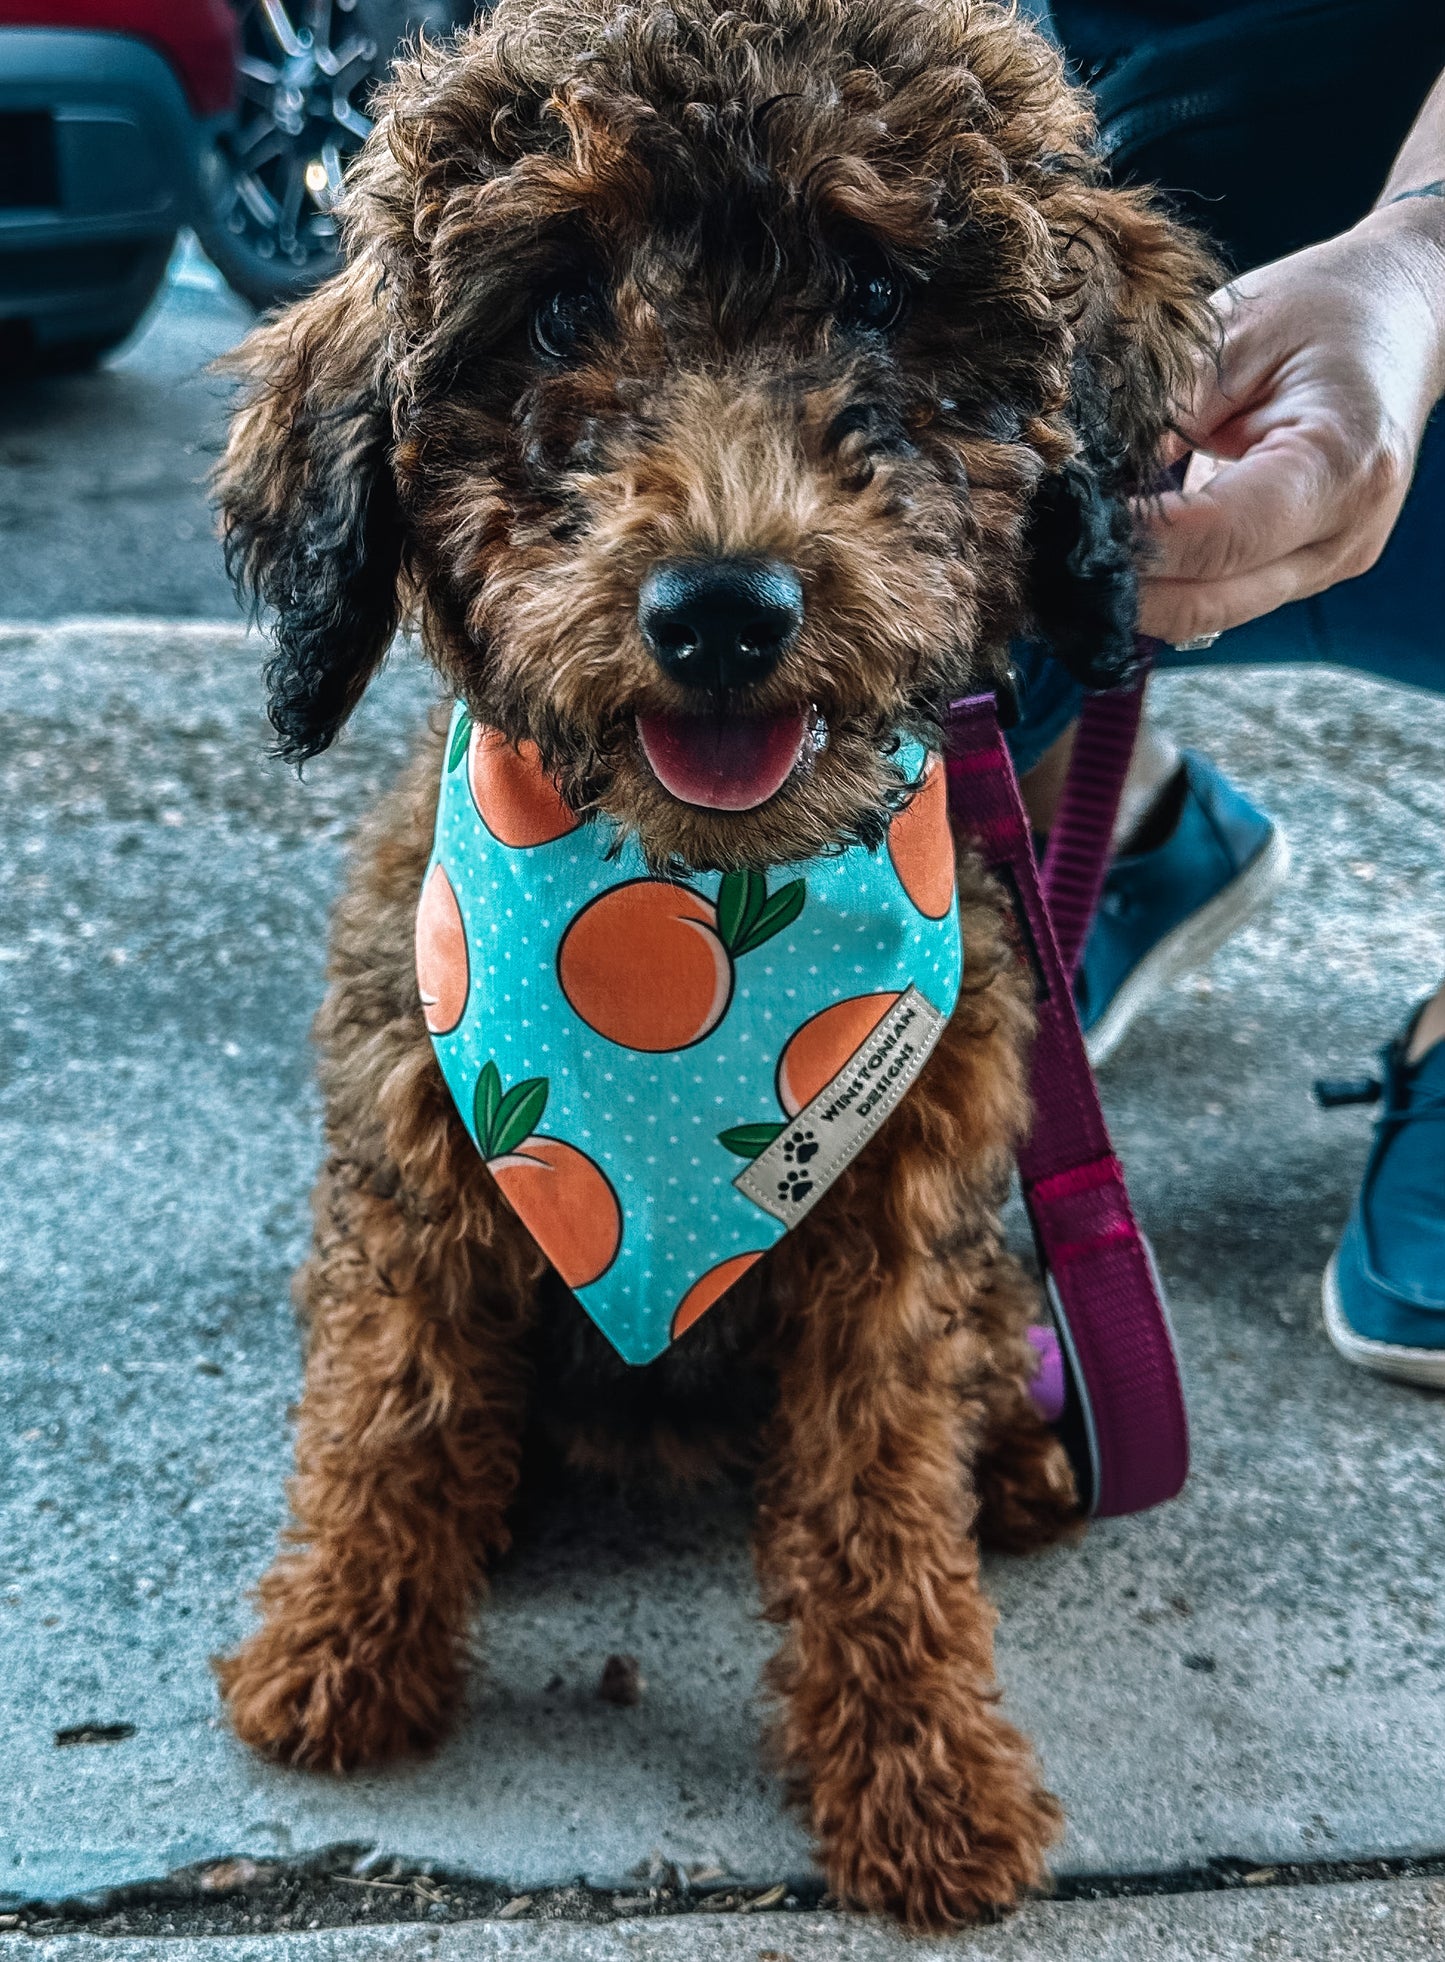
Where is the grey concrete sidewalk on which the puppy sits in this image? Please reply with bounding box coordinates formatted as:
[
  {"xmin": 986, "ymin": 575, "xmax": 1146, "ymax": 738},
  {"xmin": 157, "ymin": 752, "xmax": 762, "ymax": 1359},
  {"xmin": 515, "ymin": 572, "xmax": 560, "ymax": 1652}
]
[{"xmin": 0, "ymin": 624, "xmax": 1445, "ymax": 1930}]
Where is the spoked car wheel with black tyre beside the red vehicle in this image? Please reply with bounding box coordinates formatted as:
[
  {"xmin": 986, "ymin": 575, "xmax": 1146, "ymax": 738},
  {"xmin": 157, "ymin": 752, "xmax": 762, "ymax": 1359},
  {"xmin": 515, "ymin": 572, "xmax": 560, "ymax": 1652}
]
[{"xmin": 196, "ymin": 0, "xmax": 450, "ymax": 306}]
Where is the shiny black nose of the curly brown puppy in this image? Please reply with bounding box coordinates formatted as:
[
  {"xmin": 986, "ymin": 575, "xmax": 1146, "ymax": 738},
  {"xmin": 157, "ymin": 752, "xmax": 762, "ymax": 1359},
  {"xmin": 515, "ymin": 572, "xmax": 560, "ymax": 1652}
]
[{"xmin": 638, "ymin": 559, "xmax": 803, "ymax": 695}]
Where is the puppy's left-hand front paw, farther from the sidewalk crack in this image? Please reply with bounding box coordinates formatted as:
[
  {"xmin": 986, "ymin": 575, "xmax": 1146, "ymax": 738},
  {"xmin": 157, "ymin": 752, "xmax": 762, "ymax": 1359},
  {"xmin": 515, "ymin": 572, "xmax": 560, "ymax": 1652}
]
[{"xmin": 214, "ymin": 1585, "xmax": 461, "ymax": 1772}]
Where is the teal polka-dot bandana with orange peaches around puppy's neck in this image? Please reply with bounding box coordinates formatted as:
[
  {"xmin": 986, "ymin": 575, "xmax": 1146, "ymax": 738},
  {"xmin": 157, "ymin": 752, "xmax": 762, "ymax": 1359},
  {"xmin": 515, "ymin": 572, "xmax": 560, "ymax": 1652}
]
[{"xmin": 416, "ymin": 708, "xmax": 964, "ymax": 1364}]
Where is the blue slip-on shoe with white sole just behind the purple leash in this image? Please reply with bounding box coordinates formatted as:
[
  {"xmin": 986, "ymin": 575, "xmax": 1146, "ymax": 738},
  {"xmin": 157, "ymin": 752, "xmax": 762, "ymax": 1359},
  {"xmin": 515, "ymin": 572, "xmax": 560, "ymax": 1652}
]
[{"xmin": 1074, "ymin": 749, "xmax": 1290, "ymax": 1067}]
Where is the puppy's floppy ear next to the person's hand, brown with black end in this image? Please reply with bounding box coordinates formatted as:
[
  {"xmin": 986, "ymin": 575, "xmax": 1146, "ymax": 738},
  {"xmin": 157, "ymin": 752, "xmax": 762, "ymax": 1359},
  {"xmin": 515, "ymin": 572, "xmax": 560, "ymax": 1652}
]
[{"xmin": 1027, "ymin": 179, "xmax": 1223, "ymax": 689}]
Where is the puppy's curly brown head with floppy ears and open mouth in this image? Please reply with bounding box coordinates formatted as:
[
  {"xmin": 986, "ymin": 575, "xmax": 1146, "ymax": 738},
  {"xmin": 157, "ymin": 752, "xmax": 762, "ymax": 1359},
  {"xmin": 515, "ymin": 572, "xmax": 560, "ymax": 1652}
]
[{"xmin": 220, "ymin": 0, "xmax": 1211, "ymax": 869}]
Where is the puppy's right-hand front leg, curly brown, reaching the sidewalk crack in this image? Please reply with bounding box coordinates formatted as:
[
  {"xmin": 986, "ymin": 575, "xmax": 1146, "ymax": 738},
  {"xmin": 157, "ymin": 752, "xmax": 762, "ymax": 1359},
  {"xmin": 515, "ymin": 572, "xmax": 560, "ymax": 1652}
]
[{"xmin": 758, "ymin": 1269, "xmax": 1062, "ymax": 1929}]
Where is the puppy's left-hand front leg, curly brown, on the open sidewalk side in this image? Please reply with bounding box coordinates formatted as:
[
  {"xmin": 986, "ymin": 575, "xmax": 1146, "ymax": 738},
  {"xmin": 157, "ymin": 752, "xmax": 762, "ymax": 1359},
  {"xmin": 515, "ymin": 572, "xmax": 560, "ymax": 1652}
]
[{"xmin": 216, "ymin": 1169, "xmax": 528, "ymax": 1770}]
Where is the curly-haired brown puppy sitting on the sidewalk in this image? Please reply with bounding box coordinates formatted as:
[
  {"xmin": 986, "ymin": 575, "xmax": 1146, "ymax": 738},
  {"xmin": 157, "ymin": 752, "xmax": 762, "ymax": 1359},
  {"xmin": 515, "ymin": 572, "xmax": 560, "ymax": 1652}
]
[{"xmin": 209, "ymin": 0, "xmax": 1211, "ymax": 1927}]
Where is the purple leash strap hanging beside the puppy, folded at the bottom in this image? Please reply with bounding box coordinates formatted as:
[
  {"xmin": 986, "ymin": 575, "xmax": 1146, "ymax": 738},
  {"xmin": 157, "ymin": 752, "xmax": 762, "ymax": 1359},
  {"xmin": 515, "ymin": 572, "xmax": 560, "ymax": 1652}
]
[{"xmin": 948, "ymin": 685, "xmax": 1190, "ymax": 1519}]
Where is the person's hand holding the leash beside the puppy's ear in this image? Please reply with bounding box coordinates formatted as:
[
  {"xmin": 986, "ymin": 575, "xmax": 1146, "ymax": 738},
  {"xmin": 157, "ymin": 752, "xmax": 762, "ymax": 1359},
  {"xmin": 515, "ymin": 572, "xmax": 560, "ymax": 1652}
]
[{"xmin": 1139, "ymin": 200, "xmax": 1445, "ymax": 642}]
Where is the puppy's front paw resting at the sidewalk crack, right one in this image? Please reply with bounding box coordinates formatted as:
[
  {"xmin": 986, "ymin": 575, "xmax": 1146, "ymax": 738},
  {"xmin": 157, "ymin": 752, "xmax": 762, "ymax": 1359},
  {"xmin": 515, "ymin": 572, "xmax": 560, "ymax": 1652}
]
[{"xmin": 815, "ymin": 1725, "xmax": 1064, "ymax": 1933}]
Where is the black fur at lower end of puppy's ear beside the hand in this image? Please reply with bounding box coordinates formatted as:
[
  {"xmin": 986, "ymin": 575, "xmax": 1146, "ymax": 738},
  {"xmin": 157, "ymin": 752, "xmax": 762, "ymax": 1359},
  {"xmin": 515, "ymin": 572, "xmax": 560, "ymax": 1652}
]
[{"xmin": 1025, "ymin": 371, "xmax": 1139, "ymax": 689}]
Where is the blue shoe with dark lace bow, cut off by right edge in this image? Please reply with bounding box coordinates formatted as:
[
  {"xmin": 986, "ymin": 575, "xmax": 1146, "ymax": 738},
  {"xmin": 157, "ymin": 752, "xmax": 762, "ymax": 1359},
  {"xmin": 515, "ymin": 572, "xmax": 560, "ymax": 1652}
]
[{"xmin": 1315, "ymin": 1010, "xmax": 1445, "ymax": 1389}]
